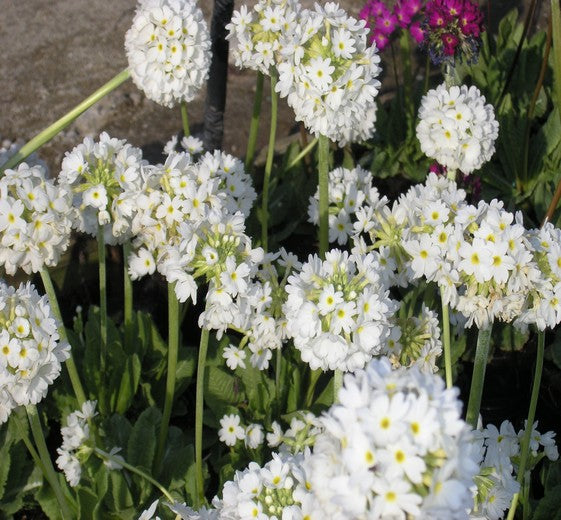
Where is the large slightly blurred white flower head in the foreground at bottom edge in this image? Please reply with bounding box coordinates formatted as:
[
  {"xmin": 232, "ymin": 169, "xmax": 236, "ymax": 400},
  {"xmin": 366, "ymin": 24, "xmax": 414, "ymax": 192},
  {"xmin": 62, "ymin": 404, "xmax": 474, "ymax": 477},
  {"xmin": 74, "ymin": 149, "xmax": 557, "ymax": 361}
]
[{"xmin": 303, "ymin": 359, "xmax": 479, "ymax": 520}]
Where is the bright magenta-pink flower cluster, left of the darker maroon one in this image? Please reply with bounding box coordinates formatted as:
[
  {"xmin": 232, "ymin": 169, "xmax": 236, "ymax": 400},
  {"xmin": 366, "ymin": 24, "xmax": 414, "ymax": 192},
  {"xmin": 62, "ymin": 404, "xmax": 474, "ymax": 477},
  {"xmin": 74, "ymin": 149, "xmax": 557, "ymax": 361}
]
[{"xmin": 360, "ymin": 0, "xmax": 424, "ymax": 51}]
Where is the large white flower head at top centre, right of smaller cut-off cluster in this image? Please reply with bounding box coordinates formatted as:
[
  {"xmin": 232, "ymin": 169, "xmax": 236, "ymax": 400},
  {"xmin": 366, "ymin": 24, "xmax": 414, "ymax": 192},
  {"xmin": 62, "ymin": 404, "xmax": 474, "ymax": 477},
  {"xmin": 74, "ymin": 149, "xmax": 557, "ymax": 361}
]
[{"xmin": 276, "ymin": 2, "xmax": 381, "ymax": 146}]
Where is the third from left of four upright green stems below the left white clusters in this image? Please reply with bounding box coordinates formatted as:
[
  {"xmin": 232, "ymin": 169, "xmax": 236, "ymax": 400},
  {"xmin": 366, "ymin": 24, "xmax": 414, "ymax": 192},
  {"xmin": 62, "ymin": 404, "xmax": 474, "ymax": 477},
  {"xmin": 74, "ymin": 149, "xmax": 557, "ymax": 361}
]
[{"xmin": 156, "ymin": 282, "xmax": 179, "ymax": 460}]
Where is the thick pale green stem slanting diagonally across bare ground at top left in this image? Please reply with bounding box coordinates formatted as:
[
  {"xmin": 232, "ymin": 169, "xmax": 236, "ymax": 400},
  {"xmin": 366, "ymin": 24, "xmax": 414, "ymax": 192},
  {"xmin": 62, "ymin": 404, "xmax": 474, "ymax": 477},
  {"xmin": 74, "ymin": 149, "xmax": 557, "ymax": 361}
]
[{"xmin": 0, "ymin": 69, "xmax": 130, "ymax": 174}]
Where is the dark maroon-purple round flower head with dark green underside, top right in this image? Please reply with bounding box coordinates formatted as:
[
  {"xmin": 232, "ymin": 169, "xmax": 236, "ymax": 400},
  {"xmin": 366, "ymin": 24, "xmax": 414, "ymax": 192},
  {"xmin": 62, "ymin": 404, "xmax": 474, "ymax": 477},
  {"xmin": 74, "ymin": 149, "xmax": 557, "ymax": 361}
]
[{"xmin": 416, "ymin": 0, "xmax": 483, "ymax": 65}]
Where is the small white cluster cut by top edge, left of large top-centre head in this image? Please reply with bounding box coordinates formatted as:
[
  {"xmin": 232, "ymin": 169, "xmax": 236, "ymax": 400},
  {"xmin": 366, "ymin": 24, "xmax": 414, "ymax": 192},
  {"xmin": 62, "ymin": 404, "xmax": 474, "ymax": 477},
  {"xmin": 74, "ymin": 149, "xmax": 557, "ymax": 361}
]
[{"xmin": 226, "ymin": 0, "xmax": 301, "ymax": 75}]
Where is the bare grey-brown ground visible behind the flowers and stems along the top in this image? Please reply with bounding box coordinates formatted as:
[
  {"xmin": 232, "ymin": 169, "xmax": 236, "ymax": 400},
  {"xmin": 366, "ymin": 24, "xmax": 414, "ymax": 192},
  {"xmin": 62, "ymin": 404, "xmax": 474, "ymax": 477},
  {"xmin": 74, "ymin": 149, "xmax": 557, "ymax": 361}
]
[{"xmin": 0, "ymin": 0, "xmax": 547, "ymax": 174}]
